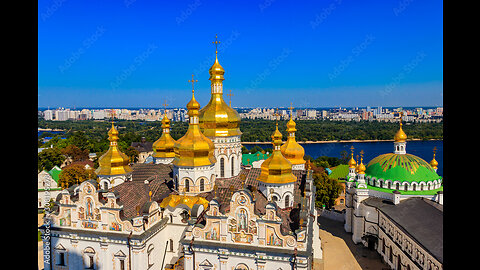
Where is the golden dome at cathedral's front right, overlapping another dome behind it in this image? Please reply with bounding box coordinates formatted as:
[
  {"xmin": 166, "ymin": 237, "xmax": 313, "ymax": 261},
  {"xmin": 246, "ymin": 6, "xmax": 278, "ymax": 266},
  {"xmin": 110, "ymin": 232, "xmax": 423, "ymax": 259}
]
[{"xmin": 257, "ymin": 124, "xmax": 297, "ymax": 184}]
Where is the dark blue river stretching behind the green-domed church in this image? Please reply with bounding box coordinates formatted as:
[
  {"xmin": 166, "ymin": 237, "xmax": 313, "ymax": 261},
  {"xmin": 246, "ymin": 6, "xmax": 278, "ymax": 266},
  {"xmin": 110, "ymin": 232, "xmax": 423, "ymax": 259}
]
[{"xmin": 244, "ymin": 140, "xmax": 443, "ymax": 176}]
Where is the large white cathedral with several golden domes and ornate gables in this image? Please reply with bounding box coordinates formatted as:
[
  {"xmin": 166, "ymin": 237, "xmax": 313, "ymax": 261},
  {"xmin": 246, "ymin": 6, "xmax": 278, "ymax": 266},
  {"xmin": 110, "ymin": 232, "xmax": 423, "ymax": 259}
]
[{"xmin": 40, "ymin": 38, "xmax": 322, "ymax": 270}]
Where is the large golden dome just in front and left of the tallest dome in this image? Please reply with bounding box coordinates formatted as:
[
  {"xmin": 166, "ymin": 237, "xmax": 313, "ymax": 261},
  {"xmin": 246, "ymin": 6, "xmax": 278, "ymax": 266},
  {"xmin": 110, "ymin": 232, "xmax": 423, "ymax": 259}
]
[{"xmin": 173, "ymin": 91, "xmax": 217, "ymax": 167}]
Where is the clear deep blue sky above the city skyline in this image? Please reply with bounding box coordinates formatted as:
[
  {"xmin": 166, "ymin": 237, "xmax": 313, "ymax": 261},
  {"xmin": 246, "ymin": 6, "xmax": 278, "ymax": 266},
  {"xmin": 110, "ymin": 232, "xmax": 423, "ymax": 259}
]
[{"xmin": 38, "ymin": 0, "xmax": 443, "ymax": 108}]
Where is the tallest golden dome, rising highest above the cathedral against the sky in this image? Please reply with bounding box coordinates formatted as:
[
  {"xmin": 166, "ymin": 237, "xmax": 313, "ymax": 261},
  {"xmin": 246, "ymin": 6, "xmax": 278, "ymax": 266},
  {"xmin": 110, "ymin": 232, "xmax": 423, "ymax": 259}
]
[{"xmin": 199, "ymin": 53, "xmax": 242, "ymax": 137}]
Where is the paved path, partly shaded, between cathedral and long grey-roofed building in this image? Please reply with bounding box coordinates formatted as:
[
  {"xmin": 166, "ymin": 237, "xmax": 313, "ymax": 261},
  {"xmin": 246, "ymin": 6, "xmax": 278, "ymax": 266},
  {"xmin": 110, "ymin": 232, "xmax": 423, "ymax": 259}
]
[{"xmin": 318, "ymin": 217, "xmax": 388, "ymax": 270}]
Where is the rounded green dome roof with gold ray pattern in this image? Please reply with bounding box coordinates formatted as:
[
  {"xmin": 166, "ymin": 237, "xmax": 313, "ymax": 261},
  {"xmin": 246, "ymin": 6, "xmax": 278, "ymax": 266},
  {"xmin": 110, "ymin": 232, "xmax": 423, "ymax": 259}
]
[{"xmin": 365, "ymin": 153, "xmax": 441, "ymax": 183}]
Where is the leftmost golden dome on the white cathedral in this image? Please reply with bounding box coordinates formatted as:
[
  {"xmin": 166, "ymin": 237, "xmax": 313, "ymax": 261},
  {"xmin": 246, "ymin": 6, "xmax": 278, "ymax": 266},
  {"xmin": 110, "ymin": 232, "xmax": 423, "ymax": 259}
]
[{"xmin": 95, "ymin": 123, "xmax": 132, "ymax": 175}]
